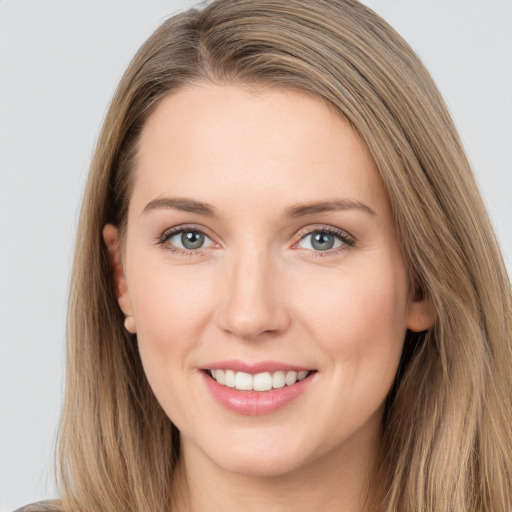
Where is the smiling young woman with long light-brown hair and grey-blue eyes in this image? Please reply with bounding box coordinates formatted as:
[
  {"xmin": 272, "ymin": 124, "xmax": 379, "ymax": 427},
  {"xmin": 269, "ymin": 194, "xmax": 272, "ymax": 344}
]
[{"xmin": 16, "ymin": 0, "xmax": 512, "ymax": 512}]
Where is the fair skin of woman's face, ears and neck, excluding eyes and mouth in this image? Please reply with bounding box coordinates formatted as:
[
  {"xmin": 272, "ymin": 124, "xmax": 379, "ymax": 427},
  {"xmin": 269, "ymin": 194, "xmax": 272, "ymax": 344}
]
[{"xmin": 104, "ymin": 84, "xmax": 433, "ymax": 511}]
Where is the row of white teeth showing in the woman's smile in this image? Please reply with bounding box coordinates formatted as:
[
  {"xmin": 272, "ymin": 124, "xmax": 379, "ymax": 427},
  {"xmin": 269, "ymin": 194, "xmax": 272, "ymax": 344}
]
[{"xmin": 206, "ymin": 369, "xmax": 314, "ymax": 391}]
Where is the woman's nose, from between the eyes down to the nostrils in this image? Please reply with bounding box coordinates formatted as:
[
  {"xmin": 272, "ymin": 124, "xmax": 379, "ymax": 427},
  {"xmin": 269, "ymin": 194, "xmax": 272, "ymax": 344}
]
[{"xmin": 217, "ymin": 248, "xmax": 290, "ymax": 339}]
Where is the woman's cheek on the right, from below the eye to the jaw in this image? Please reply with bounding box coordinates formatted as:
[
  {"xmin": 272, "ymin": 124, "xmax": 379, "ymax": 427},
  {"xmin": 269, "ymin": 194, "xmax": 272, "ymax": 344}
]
[{"xmin": 290, "ymin": 262, "xmax": 408, "ymax": 440}]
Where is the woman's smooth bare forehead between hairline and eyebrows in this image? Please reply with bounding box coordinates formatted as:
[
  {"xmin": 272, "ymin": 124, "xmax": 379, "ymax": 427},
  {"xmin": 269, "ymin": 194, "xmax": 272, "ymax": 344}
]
[{"xmin": 133, "ymin": 85, "xmax": 387, "ymax": 216}]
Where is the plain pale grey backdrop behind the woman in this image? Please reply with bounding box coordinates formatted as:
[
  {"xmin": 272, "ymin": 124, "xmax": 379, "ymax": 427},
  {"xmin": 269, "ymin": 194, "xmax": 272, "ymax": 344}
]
[{"xmin": 0, "ymin": 0, "xmax": 512, "ymax": 511}]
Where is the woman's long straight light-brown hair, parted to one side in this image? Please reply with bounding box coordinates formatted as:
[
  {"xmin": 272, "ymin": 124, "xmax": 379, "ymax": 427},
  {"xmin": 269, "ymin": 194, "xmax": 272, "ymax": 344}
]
[{"xmin": 37, "ymin": 0, "xmax": 512, "ymax": 512}]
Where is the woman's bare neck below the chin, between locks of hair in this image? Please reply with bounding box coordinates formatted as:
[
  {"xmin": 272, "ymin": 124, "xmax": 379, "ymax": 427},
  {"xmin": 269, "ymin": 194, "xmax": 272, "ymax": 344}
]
[{"xmin": 173, "ymin": 428, "xmax": 377, "ymax": 512}]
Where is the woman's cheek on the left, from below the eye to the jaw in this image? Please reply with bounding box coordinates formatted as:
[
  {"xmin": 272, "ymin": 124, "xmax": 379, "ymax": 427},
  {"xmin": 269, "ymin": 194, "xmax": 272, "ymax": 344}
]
[{"xmin": 128, "ymin": 260, "xmax": 220, "ymax": 426}]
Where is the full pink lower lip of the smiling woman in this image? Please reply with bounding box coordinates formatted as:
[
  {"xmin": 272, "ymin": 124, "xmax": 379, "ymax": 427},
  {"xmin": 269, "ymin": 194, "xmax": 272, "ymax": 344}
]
[{"xmin": 201, "ymin": 371, "xmax": 316, "ymax": 416}]
